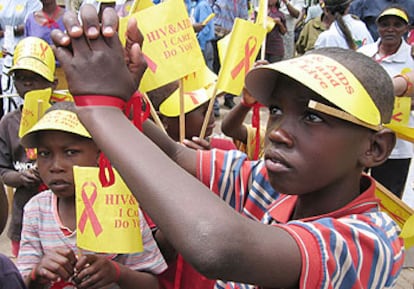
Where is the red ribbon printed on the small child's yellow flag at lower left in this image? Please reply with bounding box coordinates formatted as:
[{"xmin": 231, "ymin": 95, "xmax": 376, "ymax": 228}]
[{"xmin": 78, "ymin": 182, "xmax": 103, "ymax": 237}]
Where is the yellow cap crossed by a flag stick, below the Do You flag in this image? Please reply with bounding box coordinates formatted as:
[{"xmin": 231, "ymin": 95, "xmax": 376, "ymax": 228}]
[{"xmin": 160, "ymin": 85, "xmax": 214, "ymax": 117}]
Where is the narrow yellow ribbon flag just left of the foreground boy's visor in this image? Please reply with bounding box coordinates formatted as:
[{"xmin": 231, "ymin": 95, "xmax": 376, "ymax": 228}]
[{"xmin": 216, "ymin": 18, "xmax": 266, "ymax": 95}]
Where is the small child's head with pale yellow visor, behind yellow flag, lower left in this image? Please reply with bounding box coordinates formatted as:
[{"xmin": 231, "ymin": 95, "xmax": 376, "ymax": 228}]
[{"xmin": 21, "ymin": 102, "xmax": 99, "ymax": 198}]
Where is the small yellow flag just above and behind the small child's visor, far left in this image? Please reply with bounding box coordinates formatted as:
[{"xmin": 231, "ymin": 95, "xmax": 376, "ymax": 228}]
[{"xmin": 19, "ymin": 88, "xmax": 52, "ymax": 138}]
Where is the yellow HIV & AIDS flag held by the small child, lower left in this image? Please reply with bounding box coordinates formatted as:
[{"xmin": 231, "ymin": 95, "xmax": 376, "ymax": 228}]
[{"xmin": 73, "ymin": 166, "xmax": 143, "ymax": 254}]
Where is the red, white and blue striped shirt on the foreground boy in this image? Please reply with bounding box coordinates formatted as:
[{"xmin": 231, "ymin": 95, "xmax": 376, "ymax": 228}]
[{"xmin": 199, "ymin": 150, "xmax": 404, "ymax": 289}]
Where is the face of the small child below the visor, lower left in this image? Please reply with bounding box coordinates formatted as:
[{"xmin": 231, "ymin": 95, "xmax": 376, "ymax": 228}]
[{"xmin": 37, "ymin": 131, "xmax": 99, "ymax": 197}]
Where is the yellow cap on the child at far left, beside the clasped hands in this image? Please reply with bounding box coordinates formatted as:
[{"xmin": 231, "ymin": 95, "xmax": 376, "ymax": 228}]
[{"xmin": 9, "ymin": 36, "xmax": 55, "ymax": 82}]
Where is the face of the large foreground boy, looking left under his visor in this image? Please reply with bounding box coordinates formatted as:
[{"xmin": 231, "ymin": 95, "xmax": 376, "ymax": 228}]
[{"xmin": 264, "ymin": 79, "xmax": 372, "ymax": 195}]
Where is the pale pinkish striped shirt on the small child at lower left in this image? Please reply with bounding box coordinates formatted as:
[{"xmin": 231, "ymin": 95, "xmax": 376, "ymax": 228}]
[{"xmin": 17, "ymin": 190, "xmax": 167, "ymax": 289}]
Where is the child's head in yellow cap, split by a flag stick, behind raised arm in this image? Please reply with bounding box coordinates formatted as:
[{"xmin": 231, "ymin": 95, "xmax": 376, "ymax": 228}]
[{"xmin": 149, "ymin": 84, "xmax": 215, "ymax": 141}]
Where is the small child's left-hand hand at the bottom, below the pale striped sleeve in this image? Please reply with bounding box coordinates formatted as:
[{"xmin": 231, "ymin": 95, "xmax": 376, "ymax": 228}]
[{"xmin": 32, "ymin": 248, "xmax": 76, "ymax": 284}]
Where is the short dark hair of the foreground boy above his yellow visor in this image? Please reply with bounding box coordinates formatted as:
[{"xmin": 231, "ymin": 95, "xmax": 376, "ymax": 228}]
[{"xmin": 307, "ymin": 47, "xmax": 394, "ymax": 123}]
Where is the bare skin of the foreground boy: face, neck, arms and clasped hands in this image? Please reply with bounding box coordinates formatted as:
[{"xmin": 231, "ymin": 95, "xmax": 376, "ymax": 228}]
[{"xmin": 53, "ymin": 6, "xmax": 395, "ymax": 288}]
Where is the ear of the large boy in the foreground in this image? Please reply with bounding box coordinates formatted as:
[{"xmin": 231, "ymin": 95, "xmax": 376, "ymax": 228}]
[{"xmin": 360, "ymin": 128, "xmax": 396, "ymax": 168}]
